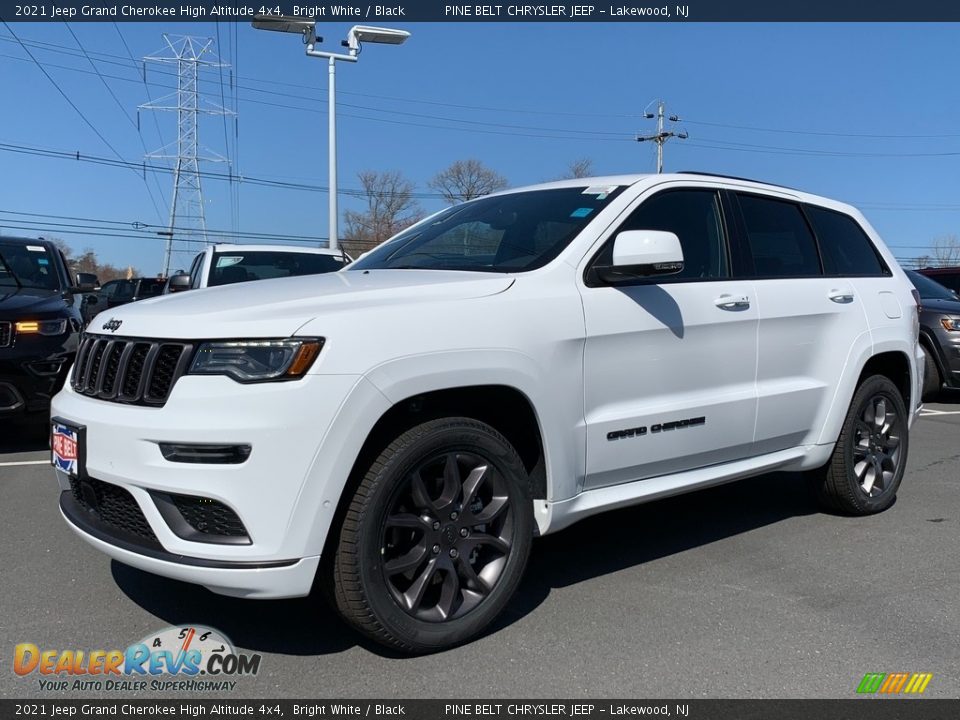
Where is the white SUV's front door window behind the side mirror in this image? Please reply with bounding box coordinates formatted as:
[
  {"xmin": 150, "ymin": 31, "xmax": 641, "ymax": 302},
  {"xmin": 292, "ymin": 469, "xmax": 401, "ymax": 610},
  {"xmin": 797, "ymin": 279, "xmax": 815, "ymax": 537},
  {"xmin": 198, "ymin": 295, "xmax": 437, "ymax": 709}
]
[{"xmin": 594, "ymin": 189, "xmax": 729, "ymax": 280}]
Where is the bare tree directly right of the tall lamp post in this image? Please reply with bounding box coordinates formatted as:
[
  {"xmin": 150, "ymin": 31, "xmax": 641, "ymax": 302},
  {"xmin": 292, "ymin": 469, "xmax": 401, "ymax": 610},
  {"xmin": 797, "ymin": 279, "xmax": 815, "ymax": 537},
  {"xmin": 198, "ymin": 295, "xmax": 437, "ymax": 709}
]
[{"xmin": 342, "ymin": 170, "xmax": 421, "ymax": 254}]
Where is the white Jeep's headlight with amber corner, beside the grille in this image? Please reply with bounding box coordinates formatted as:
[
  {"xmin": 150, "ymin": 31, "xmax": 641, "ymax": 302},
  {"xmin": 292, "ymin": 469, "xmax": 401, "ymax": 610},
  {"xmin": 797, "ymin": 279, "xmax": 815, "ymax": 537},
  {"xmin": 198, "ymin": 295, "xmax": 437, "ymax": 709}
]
[{"xmin": 189, "ymin": 338, "xmax": 323, "ymax": 383}]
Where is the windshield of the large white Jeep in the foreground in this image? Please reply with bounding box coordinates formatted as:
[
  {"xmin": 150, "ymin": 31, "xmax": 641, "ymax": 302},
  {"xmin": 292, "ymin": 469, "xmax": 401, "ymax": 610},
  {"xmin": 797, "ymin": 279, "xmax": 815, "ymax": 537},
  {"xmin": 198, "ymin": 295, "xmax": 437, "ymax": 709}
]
[{"xmin": 348, "ymin": 186, "xmax": 623, "ymax": 273}]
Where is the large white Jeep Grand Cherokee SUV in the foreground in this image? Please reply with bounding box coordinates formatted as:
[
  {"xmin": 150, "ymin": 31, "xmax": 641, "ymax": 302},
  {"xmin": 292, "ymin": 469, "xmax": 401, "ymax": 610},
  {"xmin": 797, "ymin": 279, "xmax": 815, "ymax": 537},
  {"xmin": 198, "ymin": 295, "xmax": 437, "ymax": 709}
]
[{"xmin": 52, "ymin": 174, "xmax": 924, "ymax": 652}]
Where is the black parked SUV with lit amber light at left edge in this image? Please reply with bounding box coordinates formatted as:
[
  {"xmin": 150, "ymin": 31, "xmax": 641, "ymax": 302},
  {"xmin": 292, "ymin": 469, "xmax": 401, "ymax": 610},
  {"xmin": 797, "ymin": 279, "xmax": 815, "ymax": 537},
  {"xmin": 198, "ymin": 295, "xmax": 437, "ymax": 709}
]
[{"xmin": 0, "ymin": 237, "xmax": 97, "ymax": 420}]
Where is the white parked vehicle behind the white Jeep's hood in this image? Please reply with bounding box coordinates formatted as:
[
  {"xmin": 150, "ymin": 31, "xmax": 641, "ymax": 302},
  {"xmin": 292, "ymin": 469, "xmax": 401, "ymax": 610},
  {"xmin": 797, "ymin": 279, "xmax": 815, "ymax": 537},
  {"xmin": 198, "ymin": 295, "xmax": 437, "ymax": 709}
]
[{"xmin": 164, "ymin": 245, "xmax": 353, "ymax": 292}]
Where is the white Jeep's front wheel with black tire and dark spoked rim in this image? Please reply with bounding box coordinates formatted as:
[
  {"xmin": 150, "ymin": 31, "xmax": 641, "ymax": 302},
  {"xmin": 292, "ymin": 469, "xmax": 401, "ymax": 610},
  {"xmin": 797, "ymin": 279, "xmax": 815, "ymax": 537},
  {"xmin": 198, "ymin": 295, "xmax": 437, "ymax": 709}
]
[{"xmin": 333, "ymin": 418, "xmax": 533, "ymax": 653}]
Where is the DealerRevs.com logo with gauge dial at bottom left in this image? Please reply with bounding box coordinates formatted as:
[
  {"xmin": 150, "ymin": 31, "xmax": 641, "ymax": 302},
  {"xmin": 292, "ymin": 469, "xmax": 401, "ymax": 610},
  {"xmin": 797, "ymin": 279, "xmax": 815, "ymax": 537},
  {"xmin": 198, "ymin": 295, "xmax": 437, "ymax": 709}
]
[{"xmin": 13, "ymin": 625, "xmax": 261, "ymax": 692}]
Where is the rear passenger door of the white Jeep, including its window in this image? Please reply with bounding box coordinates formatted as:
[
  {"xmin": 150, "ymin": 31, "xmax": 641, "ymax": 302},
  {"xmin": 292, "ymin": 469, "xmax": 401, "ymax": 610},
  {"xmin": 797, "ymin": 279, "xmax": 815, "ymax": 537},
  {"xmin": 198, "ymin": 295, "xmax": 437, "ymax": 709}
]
[{"xmin": 732, "ymin": 192, "xmax": 869, "ymax": 454}]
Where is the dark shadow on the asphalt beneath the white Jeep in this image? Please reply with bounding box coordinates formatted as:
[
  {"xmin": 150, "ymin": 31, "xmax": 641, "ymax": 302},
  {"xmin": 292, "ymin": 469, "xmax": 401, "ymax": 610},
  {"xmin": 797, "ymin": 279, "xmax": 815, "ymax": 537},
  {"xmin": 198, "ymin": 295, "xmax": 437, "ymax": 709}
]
[{"xmin": 112, "ymin": 473, "xmax": 818, "ymax": 657}]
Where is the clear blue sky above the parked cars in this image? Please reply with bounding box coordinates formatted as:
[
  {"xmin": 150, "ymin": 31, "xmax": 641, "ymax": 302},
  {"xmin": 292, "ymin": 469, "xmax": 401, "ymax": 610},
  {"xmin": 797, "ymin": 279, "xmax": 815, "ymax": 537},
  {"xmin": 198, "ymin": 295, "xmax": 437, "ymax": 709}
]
[{"xmin": 0, "ymin": 23, "xmax": 960, "ymax": 274}]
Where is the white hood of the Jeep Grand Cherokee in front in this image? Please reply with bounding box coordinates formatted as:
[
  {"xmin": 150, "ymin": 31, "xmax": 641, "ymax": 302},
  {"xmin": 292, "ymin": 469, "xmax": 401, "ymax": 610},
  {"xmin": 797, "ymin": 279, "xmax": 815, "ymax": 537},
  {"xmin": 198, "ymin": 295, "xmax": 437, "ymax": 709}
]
[{"xmin": 88, "ymin": 270, "xmax": 514, "ymax": 340}]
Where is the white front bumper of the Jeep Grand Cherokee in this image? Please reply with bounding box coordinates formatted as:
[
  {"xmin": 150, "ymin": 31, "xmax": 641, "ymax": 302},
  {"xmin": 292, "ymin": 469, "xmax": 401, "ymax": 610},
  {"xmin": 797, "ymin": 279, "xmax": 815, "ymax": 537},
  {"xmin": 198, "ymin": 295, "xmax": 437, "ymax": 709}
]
[{"xmin": 52, "ymin": 368, "xmax": 382, "ymax": 598}]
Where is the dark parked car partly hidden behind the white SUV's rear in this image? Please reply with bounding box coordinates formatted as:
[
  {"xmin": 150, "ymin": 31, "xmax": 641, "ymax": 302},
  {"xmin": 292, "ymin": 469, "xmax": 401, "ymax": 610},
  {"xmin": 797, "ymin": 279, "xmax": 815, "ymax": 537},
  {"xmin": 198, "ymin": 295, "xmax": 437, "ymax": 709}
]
[{"xmin": 906, "ymin": 270, "xmax": 960, "ymax": 398}]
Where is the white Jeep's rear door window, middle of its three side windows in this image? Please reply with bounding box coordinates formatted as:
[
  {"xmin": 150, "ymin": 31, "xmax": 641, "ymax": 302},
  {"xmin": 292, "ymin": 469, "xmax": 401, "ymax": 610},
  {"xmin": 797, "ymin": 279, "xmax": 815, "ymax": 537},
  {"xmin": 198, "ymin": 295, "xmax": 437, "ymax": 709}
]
[{"xmin": 737, "ymin": 194, "xmax": 821, "ymax": 278}]
